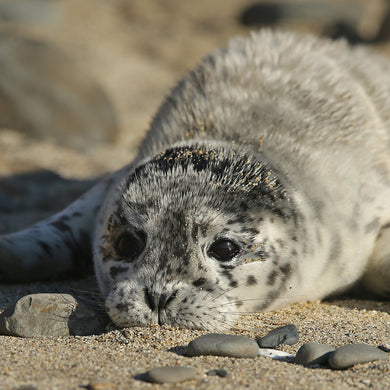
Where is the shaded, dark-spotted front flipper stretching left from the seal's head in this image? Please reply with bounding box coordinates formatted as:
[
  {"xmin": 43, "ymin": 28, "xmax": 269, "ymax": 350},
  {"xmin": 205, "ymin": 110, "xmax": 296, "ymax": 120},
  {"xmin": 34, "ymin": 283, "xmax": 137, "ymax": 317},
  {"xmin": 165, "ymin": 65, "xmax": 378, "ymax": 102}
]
[{"xmin": 0, "ymin": 179, "xmax": 107, "ymax": 282}]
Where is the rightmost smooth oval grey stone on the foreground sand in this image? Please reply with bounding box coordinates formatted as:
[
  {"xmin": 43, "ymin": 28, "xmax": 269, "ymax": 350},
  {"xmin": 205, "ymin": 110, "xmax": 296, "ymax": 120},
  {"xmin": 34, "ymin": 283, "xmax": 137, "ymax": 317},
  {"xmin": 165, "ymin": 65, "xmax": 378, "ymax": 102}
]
[{"xmin": 329, "ymin": 344, "xmax": 389, "ymax": 370}]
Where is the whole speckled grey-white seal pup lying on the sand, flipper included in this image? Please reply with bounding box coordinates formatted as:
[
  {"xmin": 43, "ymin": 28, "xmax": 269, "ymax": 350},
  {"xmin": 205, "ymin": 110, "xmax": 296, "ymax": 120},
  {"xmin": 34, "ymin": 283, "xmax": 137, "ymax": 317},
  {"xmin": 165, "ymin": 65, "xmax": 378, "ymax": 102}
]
[{"xmin": 0, "ymin": 31, "xmax": 390, "ymax": 330}]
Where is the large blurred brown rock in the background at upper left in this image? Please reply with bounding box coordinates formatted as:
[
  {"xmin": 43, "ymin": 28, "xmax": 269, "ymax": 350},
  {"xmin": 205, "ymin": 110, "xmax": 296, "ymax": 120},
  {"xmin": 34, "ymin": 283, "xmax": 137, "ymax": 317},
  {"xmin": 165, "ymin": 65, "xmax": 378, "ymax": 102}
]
[{"xmin": 0, "ymin": 31, "xmax": 117, "ymax": 149}]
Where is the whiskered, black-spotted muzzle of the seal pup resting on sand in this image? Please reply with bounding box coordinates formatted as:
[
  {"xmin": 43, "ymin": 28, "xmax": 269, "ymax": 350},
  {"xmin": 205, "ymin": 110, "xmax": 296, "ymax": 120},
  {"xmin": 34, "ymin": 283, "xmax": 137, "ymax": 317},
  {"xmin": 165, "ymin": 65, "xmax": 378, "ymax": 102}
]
[{"xmin": 105, "ymin": 281, "xmax": 242, "ymax": 331}]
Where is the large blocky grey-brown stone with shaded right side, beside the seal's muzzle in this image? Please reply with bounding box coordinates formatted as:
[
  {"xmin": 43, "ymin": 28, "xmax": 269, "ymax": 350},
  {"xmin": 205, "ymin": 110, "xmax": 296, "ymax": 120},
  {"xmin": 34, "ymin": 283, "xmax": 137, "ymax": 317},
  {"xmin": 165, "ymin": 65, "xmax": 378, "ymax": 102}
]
[{"xmin": 0, "ymin": 294, "xmax": 108, "ymax": 337}]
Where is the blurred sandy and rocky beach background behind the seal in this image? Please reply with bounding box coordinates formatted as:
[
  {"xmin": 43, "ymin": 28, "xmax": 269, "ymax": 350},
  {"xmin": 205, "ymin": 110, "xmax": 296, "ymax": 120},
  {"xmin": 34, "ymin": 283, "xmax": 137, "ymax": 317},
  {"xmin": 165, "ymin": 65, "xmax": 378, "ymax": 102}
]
[{"xmin": 0, "ymin": 0, "xmax": 390, "ymax": 232}]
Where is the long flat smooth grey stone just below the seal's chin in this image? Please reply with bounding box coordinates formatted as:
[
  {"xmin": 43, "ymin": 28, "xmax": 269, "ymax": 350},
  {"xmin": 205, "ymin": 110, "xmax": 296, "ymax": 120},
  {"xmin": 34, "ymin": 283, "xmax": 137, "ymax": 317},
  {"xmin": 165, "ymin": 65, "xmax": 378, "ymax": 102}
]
[{"xmin": 186, "ymin": 333, "xmax": 259, "ymax": 358}]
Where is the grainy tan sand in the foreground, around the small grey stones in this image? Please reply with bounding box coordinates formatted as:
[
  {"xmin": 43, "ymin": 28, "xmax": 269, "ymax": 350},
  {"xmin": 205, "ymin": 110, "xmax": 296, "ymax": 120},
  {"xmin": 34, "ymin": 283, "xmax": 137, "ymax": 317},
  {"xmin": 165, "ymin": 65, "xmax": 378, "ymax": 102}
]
[{"xmin": 0, "ymin": 300, "xmax": 390, "ymax": 390}]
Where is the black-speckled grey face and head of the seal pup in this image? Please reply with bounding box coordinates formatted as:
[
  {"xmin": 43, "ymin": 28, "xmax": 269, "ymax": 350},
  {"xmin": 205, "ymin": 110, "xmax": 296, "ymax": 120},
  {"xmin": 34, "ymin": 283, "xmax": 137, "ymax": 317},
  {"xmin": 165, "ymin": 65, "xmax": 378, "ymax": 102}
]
[{"xmin": 95, "ymin": 147, "xmax": 298, "ymax": 330}]
